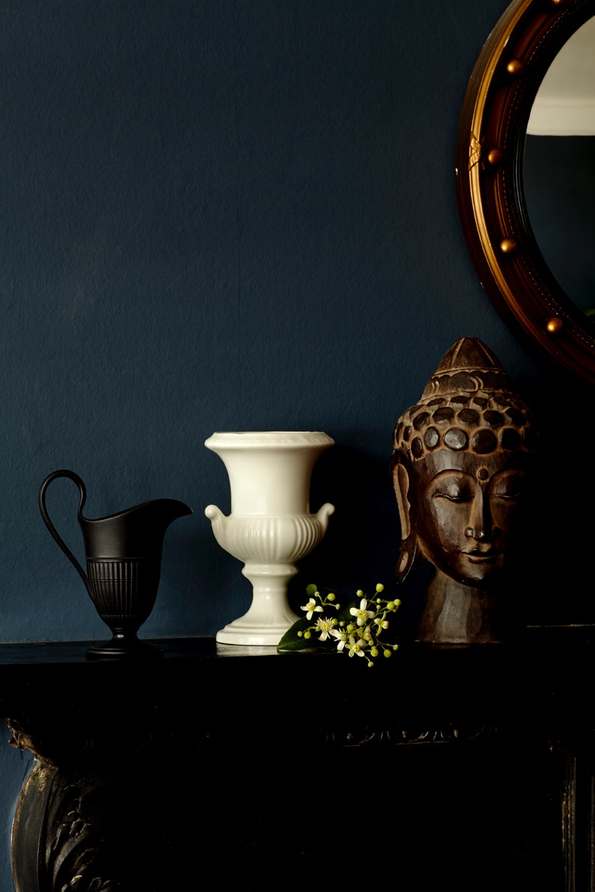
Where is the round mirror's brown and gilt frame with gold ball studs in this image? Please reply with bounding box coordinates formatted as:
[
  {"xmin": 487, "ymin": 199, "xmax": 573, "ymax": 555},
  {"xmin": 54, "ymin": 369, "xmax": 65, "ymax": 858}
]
[{"xmin": 456, "ymin": 0, "xmax": 595, "ymax": 384}]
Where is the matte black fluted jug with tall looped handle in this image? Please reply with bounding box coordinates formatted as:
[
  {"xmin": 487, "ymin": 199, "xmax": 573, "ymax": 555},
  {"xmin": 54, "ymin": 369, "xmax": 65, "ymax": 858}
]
[{"xmin": 39, "ymin": 469, "xmax": 192, "ymax": 656}]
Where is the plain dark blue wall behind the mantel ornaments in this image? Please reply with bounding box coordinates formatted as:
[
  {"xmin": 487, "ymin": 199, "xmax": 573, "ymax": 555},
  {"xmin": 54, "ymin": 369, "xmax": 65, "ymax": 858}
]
[{"xmin": 0, "ymin": 0, "xmax": 588, "ymax": 890}]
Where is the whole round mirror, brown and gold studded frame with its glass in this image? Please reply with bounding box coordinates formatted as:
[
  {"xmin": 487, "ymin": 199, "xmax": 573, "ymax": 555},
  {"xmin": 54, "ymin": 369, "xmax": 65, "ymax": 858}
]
[{"xmin": 456, "ymin": 0, "xmax": 595, "ymax": 383}]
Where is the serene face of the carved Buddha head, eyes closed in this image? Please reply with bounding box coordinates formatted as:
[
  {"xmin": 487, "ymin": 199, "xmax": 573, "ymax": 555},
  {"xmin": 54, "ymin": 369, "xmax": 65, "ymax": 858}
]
[{"xmin": 400, "ymin": 448, "xmax": 524, "ymax": 586}]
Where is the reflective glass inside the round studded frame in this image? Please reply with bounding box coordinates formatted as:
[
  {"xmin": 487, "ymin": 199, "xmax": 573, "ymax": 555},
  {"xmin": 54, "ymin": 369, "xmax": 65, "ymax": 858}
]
[{"xmin": 523, "ymin": 17, "xmax": 595, "ymax": 328}]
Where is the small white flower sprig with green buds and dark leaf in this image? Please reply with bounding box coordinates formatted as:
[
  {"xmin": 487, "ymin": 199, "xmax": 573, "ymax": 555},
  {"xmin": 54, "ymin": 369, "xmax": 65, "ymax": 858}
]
[{"xmin": 279, "ymin": 582, "xmax": 401, "ymax": 667}]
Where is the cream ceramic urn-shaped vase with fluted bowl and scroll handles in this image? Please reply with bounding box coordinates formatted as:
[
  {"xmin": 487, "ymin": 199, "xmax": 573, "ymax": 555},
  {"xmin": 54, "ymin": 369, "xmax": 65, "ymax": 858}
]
[{"xmin": 205, "ymin": 431, "xmax": 335, "ymax": 646}]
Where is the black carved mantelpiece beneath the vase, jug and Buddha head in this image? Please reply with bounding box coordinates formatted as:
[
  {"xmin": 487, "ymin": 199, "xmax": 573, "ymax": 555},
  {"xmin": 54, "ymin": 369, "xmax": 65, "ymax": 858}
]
[{"xmin": 0, "ymin": 627, "xmax": 595, "ymax": 892}]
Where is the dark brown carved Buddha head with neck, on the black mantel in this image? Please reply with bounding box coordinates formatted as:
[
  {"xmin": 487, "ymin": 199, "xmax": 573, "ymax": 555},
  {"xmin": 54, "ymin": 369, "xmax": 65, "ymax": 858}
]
[{"xmin": 393, "ymin": 338, "xmax": 534, "ymax": 644}]
